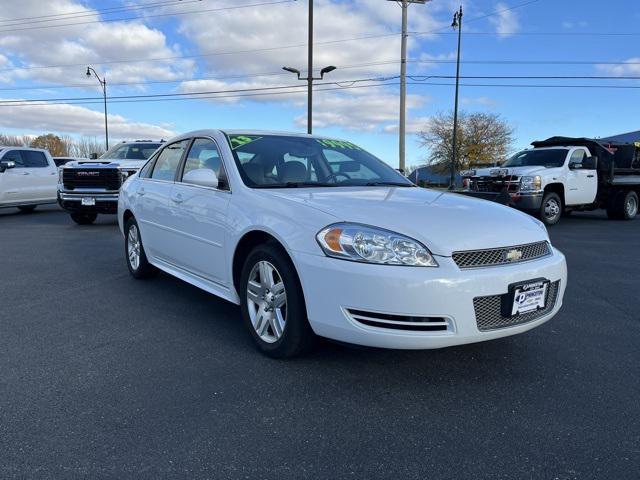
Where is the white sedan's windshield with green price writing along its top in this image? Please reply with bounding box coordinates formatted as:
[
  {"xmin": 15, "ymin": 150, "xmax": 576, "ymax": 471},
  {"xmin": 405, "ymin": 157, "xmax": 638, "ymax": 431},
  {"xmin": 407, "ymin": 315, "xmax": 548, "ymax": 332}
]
[{"xmin": 227, "ymin": 134, "xmax": 414, "ymax": 188}]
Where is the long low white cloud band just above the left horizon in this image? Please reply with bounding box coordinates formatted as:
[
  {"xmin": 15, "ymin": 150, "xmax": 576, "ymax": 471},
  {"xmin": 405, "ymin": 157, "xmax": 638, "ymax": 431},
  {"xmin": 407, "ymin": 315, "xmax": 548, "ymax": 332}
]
[{"xmin": 0, "ymin": 98, "xmax": 174, "ymax": 139}]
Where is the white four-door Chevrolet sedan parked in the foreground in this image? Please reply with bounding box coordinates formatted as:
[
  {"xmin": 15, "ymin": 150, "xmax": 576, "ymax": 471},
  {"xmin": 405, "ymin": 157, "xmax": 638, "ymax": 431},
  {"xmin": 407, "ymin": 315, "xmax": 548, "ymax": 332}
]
[{"xmin": 118, "ymin": 130, "xmax": 567, "ymax": 357}]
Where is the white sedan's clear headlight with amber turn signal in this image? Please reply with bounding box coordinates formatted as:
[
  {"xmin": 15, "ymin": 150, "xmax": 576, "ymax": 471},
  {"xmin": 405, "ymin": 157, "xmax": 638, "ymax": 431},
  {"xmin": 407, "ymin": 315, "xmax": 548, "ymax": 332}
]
[{"xmin": 316, "ymin": 223, "xmax": 438, "ymax": 267}]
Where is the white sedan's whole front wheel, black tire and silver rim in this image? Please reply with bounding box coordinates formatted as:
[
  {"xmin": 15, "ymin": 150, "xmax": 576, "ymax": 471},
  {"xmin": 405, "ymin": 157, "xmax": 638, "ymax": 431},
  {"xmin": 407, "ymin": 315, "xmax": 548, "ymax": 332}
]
[{"xmin": 238, "ymin": 243, "xmax": 315, "ymax": 358}]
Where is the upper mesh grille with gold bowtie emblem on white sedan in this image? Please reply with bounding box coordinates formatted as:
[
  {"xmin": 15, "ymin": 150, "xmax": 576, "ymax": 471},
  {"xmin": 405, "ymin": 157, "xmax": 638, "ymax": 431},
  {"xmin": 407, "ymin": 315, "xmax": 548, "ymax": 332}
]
[{"xmin": 452, "ymin": 242, "xmax": 551, "ymax": 268}]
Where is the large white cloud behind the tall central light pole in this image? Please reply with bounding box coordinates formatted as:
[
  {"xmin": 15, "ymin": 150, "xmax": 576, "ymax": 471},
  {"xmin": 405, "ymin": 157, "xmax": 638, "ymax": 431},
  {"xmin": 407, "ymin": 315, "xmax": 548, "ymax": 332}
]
[{"xmin": 180, "ymin": 0, "xmax": 442, "ymax": 131}]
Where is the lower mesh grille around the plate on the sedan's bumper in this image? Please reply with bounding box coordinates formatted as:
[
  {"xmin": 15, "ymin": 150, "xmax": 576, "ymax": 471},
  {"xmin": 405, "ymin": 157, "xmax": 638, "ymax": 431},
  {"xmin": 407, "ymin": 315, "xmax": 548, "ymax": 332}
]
[{"xmin": 473, "ymin": 281, "xmax": 560, "ymax": 332}]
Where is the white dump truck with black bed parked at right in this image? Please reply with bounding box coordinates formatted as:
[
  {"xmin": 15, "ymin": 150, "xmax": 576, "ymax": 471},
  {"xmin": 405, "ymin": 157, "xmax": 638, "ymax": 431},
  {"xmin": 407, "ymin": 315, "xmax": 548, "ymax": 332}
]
[{"xmin": 460, "ymin": 137, "xmax": 640, "ymax": 225}]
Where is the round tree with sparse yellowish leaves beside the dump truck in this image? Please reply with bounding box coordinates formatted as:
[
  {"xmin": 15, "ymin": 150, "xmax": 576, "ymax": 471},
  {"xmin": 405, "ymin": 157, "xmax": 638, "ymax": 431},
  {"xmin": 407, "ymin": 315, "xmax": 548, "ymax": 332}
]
[{"xmin": 419, "ymin": 112, "xmax": 514, "ymax": 172}]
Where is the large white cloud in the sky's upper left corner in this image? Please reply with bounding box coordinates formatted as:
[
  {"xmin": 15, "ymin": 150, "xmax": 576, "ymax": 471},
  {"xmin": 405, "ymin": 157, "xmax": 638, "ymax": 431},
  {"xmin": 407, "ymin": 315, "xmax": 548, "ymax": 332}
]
[{"xmin": 0, "ymin": 0, "xmax": 194, "ymax": 88}]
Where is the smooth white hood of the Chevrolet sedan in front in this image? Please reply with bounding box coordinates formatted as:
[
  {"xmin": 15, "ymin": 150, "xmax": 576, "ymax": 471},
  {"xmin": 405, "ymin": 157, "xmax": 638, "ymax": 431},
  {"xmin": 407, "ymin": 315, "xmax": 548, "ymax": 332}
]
[{"xmin": 265, "ymin": 187, "xmax": 549, "ymax": 256}]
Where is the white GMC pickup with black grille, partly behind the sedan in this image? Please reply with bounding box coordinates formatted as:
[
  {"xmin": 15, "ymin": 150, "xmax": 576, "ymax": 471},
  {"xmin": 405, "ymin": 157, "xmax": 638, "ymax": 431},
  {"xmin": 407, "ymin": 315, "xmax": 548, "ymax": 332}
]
[{"xmin": 58, "ymin": 140, "xmax": 163, "ymax": 225}]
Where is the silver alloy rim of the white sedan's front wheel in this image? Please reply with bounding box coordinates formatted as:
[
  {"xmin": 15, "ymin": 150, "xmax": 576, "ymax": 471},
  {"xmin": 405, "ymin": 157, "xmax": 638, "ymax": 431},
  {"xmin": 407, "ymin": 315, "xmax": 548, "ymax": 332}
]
[{"xmin": 247, "ymin": 260, "xmax": 287, "ymax": 343}]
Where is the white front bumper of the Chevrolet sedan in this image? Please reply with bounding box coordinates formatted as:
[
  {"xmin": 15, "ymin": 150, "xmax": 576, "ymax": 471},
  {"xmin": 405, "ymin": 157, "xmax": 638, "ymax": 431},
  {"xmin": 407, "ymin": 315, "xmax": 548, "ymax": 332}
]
[{"xmin": 294, "ymin": 249, "xmax": 567, "ymax": 349}]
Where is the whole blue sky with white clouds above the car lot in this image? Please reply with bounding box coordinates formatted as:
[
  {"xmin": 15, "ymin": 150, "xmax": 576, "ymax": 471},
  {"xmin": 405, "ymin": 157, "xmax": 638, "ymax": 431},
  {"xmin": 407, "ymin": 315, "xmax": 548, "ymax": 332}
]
[{"xmin": 0, "ymin": 0, "xmax": 640, "ymax": 165}]
